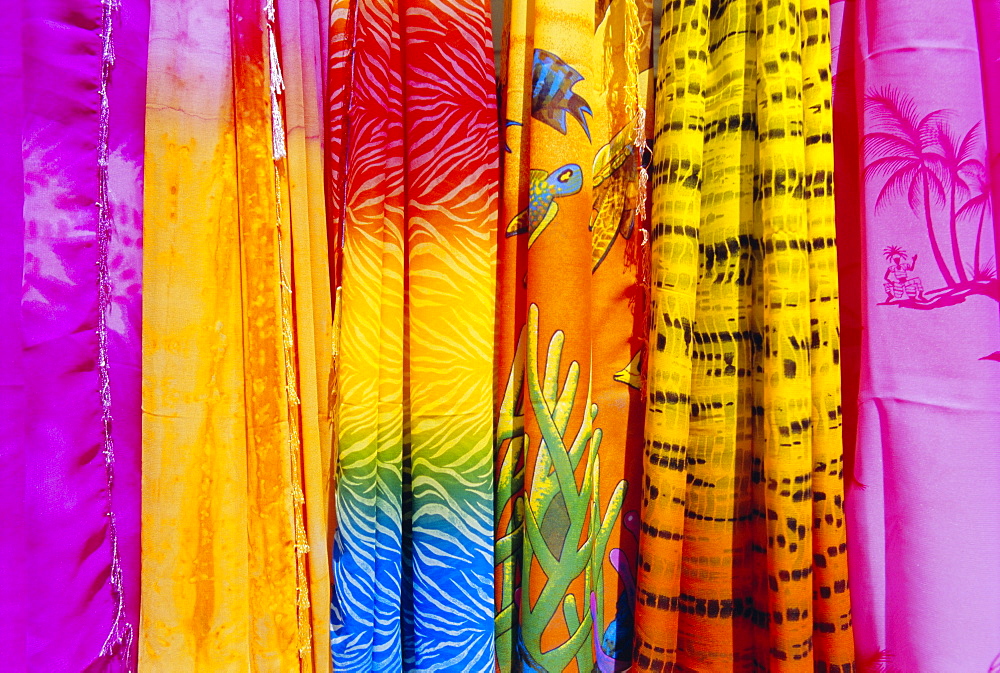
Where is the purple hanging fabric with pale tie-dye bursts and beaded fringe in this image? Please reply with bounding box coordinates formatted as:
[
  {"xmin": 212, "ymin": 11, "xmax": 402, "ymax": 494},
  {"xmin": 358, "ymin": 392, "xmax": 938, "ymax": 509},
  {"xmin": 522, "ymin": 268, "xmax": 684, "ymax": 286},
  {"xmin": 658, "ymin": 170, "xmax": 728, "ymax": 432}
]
[{"xmin": 0, "ymin": 0, "xmax": 148, "ymax": 671}]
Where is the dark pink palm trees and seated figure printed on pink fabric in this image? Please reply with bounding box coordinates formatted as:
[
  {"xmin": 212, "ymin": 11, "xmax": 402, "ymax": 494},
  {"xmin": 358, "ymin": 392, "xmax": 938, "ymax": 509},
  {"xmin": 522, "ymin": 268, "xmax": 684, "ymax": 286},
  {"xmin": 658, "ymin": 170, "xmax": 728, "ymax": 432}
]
[{"xmin": 864, "ymin": 87, "xmax": 1000, "ymax": 309}]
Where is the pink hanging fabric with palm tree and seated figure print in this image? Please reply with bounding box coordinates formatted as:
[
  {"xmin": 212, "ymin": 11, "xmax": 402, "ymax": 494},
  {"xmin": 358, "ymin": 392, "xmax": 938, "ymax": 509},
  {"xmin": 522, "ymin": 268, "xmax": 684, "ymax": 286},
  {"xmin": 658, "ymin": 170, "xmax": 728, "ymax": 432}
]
[{"xmin": 832, "ymin": 0, "xmax": 1000, "ymax": 673}]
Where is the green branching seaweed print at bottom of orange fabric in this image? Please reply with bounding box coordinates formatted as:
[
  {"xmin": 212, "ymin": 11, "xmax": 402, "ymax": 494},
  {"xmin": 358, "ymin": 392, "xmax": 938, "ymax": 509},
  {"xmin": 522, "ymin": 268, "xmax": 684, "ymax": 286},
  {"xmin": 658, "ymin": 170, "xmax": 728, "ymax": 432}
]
[{"xmin": 495, "ymin": 304, "xmax": 626, "ymax": 673}]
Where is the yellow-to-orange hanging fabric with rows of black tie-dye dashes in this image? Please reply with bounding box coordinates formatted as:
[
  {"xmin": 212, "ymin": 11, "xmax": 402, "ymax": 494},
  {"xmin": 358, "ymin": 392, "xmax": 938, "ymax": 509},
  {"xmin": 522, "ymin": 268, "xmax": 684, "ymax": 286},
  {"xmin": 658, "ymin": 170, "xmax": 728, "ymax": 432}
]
[{"xmin": 636, "ymin": 0, "xmax": 855, "ymax": 673}]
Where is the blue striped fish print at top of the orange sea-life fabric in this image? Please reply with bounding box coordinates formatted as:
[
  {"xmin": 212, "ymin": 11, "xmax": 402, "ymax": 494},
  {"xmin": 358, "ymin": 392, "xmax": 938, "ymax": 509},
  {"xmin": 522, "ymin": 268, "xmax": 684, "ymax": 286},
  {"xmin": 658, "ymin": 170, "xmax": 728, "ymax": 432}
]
[{"xmin": 531, "ymin": 49, "xmax": 594, "ymax": 140}]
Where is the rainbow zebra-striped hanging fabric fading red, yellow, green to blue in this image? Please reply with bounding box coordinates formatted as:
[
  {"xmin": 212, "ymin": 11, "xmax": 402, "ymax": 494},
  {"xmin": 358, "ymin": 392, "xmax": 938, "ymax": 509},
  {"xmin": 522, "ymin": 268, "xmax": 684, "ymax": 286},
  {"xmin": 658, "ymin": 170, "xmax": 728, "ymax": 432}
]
[{"xmin": 327, "ymin": 0, "xmax": 498, "ymax": 671}]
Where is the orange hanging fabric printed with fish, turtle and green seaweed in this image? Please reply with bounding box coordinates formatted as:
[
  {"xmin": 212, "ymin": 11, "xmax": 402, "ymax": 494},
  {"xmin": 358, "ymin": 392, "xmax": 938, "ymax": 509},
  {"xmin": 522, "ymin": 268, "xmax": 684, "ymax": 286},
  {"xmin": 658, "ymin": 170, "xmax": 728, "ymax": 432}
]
[{"xmin": 495, "ymin": 0, "xmax": 652, "ymax": 672}]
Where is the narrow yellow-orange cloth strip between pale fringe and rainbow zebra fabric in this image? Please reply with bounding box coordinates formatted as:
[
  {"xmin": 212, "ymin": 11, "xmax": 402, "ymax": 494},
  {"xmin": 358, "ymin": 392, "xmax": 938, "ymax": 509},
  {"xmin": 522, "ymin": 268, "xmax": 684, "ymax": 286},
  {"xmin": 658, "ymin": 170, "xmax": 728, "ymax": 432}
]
[{"xmin": 277, "ymin": 2, "xmax": 333, "ymax": 660}]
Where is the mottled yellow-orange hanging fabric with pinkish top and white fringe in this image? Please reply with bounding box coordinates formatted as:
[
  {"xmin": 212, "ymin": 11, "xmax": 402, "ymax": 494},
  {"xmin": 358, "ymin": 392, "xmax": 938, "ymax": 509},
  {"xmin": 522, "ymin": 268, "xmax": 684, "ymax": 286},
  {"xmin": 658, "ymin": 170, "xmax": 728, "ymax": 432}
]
[{"xmin": 139, "ymin": 0, "xmax": 332, "ymax": 671}]
